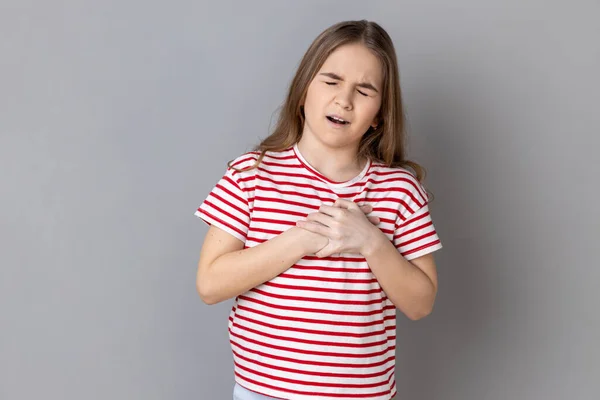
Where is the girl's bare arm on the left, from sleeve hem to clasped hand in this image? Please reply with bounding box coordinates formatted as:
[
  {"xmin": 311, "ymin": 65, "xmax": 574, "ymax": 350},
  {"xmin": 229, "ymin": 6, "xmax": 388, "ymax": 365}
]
[{"xmin": 196, "ymin": 226, "xmax": 327, "ymax": 304}]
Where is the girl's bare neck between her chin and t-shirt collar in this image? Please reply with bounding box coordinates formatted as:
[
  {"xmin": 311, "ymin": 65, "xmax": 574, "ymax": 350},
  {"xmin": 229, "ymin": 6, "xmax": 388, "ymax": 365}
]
[{"xmin": 298, "ymin": 135, "xmax": 367, "ymax": 182}]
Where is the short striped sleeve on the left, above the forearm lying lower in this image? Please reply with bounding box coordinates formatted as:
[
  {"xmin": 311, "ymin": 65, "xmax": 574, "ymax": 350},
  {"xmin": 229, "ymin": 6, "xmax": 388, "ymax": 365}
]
[{"xmin": 194, "ymin": 167, "xmax": 250, "ymax": 243}]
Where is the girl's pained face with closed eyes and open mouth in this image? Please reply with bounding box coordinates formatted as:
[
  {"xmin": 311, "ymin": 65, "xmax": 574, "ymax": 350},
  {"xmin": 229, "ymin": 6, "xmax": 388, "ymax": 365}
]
[{"xmin": 302, "ymin": 43, "xmax": 383, "ymax": 150}]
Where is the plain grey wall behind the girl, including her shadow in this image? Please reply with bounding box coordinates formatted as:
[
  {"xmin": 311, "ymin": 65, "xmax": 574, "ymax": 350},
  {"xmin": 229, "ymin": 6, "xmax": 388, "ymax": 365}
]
[{"xmin": 0, "ymin": 0, "xmax": 600, "ymax": 400}]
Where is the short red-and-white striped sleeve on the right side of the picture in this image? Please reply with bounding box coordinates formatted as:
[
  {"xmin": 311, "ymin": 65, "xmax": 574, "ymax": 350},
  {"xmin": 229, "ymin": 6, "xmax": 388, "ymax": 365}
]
[{"xmin": 393, "ymin": 176, "xmax": 442, "ymax": 260}]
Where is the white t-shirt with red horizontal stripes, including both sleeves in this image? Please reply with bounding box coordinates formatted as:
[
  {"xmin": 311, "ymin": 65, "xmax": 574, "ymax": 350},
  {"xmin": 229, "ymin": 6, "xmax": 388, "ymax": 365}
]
[{"xmin": 195, "ymin": 146, "xmax": 442, "ymax": 400}]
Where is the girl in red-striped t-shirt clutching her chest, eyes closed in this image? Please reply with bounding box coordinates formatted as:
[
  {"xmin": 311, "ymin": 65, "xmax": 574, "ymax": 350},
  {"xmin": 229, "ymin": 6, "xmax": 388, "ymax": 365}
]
[{"xmin": 195, "ymin": 21, "xmax": 442, "ymax": 400}]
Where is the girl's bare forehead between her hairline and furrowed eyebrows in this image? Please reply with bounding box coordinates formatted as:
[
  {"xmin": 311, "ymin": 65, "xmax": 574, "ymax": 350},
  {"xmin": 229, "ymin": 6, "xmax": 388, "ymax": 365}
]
[{"xmin": 319, "ymin": 43, "xmax": 383, "ymax": 86}]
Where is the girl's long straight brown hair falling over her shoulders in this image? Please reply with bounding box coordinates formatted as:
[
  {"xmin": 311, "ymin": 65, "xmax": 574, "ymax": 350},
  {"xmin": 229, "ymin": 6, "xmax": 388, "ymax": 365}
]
[{"xmin": 229, "ymin": 20, "xmax": 425, "ymax": 186}]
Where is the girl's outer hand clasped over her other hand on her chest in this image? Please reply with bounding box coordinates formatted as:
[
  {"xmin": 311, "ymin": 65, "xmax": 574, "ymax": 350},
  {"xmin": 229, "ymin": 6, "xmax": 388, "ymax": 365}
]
[{"xmin": 296, "ymin": 199, "xmax": 381, "ymax": 257}]
